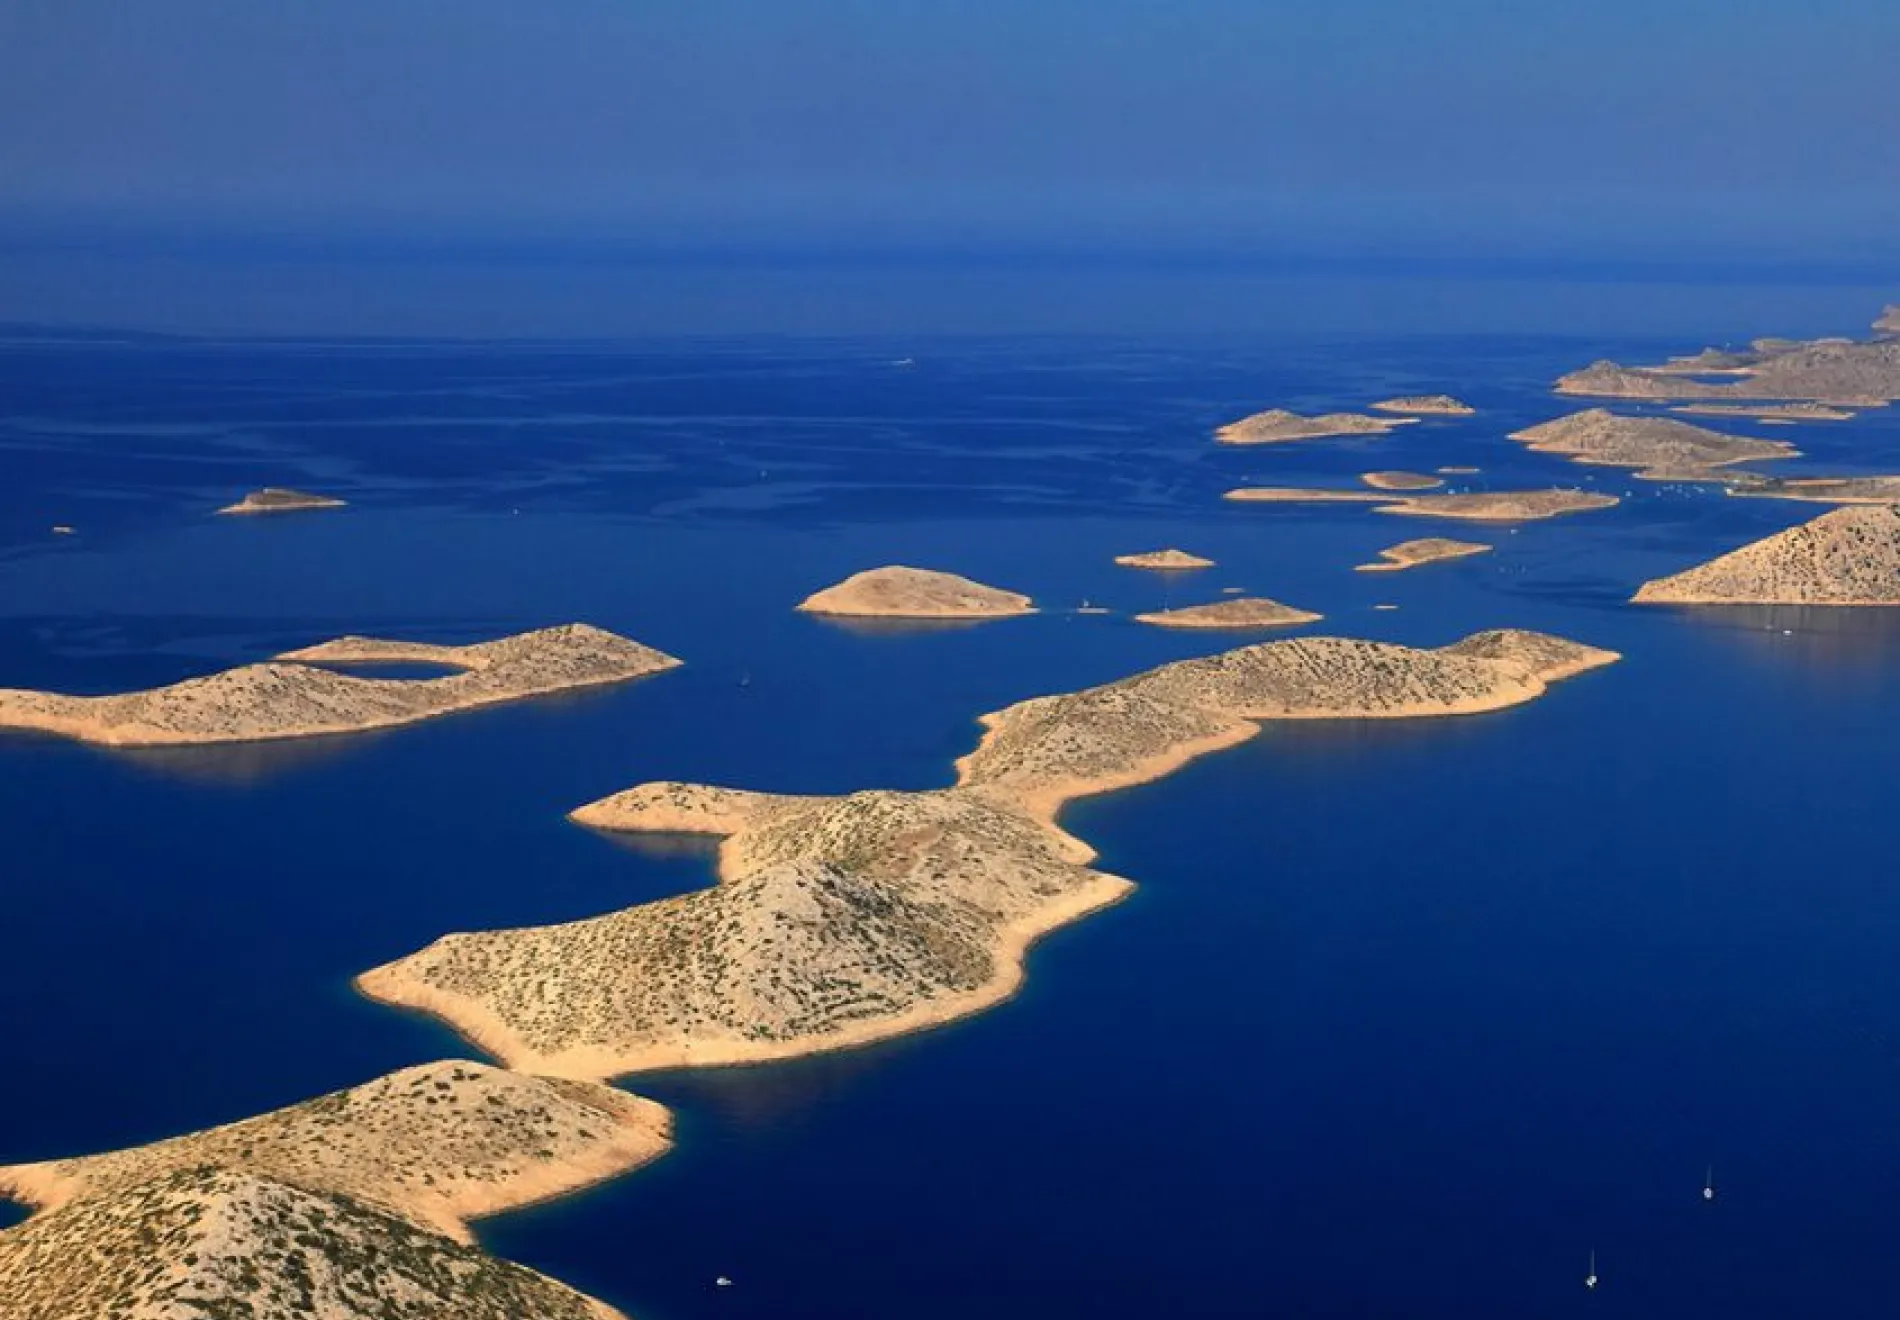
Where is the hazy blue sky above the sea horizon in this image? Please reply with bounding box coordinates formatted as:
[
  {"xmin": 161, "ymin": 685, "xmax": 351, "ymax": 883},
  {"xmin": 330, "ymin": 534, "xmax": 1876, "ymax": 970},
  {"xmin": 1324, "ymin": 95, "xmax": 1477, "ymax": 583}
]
[{"xmin": 0, "ymin": 0, "xmax": 1900, "ymax": 255}]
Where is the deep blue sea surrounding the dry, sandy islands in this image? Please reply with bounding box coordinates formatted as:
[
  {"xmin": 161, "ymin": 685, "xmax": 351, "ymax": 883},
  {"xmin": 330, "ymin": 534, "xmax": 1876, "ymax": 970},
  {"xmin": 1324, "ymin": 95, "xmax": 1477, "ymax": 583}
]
[{"xmin": 0, "ymin": 298, "xmax": 1900, "ymax": 1320}]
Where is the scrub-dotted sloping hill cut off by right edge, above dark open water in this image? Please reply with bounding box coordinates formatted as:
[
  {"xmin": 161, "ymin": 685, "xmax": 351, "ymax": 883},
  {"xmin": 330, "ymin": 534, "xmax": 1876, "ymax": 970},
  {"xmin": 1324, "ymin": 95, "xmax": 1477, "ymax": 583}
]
[{"xmin": 1636, "ymin": 503, "xmax": 1900, "ymax": 606}]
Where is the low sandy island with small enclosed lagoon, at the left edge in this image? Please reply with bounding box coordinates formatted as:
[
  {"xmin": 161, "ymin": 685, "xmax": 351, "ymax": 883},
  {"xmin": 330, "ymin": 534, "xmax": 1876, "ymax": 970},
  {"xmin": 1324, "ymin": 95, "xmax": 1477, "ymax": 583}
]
[{"xmin": 0, "ymin": 623, "xmax": 680, "ymax": 746}]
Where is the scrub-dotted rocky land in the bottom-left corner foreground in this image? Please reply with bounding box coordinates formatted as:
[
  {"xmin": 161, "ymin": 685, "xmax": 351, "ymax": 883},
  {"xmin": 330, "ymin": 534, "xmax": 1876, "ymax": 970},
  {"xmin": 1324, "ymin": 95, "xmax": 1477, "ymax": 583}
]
[{"xmin": 0, "ymin": 1062, "xmax": 671, "ymax": 1320}]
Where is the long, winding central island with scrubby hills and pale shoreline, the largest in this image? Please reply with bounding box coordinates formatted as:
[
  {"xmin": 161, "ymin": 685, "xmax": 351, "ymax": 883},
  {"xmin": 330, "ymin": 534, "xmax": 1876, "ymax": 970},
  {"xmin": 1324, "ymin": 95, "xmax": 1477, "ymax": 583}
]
[{"xmin": 357, "ymin": 632, "xmax": 1617, "ymax": 1079}]
